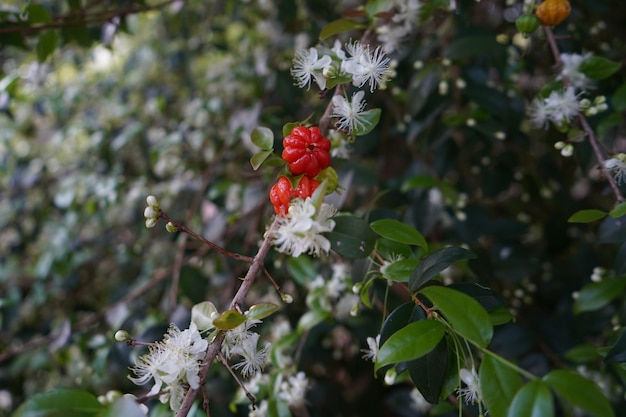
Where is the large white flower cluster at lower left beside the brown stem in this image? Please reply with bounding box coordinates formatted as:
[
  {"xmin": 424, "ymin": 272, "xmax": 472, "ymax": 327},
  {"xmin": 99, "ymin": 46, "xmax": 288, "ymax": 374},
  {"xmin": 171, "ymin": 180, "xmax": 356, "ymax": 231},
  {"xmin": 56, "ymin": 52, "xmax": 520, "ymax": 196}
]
[{"xmin": 129, "ymin": 323, "xmax": 208, "ymax": 410}]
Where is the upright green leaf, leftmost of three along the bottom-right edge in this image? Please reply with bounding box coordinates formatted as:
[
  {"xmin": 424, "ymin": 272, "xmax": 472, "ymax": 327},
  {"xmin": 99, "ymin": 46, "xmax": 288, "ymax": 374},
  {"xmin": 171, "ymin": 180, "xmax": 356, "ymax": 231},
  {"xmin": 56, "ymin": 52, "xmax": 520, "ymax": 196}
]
[{"xmin": 479, "ymin": 355, "xmax": 524, "ymax": 417}]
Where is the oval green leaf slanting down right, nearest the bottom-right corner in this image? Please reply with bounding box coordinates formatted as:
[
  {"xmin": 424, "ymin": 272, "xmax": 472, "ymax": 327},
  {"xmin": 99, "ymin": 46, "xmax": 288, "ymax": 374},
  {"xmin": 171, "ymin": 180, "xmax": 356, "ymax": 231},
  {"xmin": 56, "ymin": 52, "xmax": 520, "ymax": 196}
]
[{"xmin": 543, "ymin": 369, "xmax": 615, "ymax": 417}]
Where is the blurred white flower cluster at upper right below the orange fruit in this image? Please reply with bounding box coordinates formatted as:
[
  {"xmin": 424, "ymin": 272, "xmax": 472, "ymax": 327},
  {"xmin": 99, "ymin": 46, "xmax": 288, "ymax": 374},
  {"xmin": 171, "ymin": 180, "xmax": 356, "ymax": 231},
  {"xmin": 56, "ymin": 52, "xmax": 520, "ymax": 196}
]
[{"xmin": 529, "ymin": 86, "xmax": 581, "ymax": 128}]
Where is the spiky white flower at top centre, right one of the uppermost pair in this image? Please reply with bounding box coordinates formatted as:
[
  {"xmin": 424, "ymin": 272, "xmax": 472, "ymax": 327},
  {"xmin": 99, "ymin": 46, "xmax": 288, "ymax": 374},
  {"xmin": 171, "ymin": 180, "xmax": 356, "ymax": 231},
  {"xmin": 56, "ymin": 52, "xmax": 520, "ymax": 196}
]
[{"xmin": 341, "ymin": 42, "xmax": 389, "ymax": 92}]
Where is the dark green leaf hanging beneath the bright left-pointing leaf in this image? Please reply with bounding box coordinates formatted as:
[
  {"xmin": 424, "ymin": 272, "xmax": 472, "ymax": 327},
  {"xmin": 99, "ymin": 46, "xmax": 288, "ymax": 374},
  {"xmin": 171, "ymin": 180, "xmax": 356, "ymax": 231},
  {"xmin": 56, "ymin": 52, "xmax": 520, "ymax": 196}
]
[{"xmin": 407, "ymin": 337, "xmax": 450, "ymax": 404}]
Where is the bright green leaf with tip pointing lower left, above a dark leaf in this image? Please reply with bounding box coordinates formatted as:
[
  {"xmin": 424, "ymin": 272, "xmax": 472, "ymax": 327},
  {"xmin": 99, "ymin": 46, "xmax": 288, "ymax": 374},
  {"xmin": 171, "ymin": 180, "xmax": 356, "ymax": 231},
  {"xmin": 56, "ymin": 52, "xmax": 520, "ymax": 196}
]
[{"xmin": 375, "ymin": 320, "xmax": 446, "ymax": 370}]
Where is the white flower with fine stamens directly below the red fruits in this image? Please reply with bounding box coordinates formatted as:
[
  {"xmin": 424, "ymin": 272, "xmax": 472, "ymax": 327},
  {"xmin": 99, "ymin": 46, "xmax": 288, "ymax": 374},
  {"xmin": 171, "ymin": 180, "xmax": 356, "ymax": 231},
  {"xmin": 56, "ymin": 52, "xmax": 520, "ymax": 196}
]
[{"xmin": 274, "ymin": 198, "xmax": 336, "ymax": 257}]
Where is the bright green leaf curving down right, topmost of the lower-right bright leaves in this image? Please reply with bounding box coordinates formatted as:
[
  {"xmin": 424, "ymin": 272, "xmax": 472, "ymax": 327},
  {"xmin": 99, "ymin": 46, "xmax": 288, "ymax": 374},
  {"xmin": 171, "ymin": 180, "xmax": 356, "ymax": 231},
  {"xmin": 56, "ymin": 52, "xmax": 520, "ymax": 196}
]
[{"xmin": 420, "ymin": 285, "xmax": 493, "ymax": 347}]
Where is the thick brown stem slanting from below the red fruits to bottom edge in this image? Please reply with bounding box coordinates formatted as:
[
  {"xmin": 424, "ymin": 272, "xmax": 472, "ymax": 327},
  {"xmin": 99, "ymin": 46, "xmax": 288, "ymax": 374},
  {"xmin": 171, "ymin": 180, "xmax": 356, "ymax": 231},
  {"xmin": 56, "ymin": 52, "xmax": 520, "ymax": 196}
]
[{"xmin": 176, "ymin": 218, "xmax": 277, "ymax": 417}]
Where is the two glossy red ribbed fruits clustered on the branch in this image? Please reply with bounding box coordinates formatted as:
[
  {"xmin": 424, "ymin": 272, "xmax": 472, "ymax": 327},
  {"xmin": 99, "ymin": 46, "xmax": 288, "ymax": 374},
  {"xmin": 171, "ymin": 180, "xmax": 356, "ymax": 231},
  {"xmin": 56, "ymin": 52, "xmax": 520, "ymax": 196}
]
[{"xmin": 270, "ymin": 126, "xmax": 330, "ymax": 216}]
